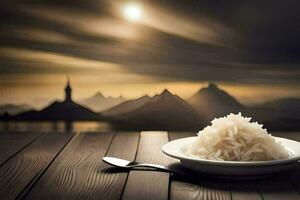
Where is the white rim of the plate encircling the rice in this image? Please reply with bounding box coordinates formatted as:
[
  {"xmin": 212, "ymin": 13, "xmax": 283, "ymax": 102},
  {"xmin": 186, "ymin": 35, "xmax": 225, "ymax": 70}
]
[{"xmin": 161, "ymin": 136, "xmax": 300, "ymax": 167}]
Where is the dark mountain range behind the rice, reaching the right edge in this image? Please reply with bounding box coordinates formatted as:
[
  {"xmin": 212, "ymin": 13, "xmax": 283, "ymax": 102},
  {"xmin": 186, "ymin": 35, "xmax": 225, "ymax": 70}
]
[{"xmin": 102, "ymin": 83, "xmax": 300, "ymax": 130}]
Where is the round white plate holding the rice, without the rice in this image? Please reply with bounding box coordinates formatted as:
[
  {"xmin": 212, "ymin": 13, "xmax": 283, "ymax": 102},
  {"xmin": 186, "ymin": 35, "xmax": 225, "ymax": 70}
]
[{"xmin": 162, "ymin": 137, "xmax": 300, "ymax": 176}]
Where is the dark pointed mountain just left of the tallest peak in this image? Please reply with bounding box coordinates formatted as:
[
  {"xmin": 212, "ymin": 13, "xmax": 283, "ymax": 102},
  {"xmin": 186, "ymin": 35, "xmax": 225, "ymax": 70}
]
[{"xmin": 105, "ymin": 90, "xmax": 201, "ymax": 130}]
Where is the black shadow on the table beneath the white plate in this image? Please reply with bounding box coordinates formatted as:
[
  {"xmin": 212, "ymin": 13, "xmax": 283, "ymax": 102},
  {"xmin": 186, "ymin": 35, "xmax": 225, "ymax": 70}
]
[{"xmin": 169, "ymin": 163, "xmax": 300, "ymax": 193}]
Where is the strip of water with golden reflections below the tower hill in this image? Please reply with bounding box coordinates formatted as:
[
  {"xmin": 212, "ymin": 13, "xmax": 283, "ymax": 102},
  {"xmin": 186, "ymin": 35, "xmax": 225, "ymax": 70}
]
[{"xmin": 0, "ymin": 121, "xmax": 113, "ymax": 132}]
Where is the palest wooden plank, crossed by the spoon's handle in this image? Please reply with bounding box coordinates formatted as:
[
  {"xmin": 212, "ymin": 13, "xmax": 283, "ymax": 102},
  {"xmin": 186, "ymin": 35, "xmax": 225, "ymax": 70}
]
[{"xmin": 122, "ymin": 131, "xmax": 173, "ymax": 200}]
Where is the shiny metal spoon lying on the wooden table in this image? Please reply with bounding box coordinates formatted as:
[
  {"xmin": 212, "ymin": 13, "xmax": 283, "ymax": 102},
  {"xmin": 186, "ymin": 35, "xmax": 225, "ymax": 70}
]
[{"xmin": 102, "ymin": 157, "xmax": 172, "ymax": 172}]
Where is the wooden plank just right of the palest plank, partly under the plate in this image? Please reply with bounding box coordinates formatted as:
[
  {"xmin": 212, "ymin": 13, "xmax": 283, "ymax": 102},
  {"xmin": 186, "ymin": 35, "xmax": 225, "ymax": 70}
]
[{"xmin": 169, "ymin": 132, "xmax": 231, "ymax": 200}]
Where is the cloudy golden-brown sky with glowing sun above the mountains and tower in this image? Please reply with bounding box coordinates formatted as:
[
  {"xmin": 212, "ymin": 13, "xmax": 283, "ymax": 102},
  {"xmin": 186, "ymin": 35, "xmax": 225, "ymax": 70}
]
[{"xmin": 0, "ymin": 0, "xmax": 300, "ymax": 105}]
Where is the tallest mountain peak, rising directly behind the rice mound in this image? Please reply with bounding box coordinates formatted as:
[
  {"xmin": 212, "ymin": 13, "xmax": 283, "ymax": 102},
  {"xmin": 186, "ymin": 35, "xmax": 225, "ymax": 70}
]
[{"xmin": 187, "ymin": 83, "xmax": 244, "ymax": 122}]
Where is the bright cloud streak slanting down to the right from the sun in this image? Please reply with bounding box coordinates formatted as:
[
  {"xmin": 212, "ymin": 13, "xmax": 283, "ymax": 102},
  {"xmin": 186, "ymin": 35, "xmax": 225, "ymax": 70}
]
[{"xmin": 123, "ymin": 4, "xmax": 233, "ymax": 46}]
